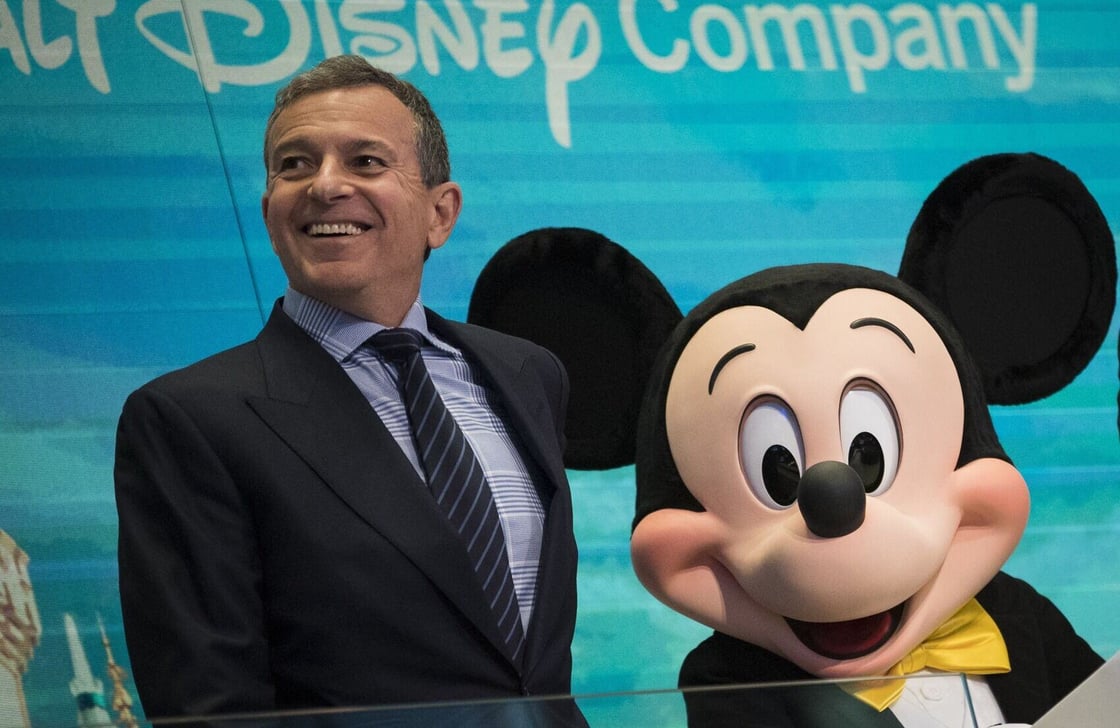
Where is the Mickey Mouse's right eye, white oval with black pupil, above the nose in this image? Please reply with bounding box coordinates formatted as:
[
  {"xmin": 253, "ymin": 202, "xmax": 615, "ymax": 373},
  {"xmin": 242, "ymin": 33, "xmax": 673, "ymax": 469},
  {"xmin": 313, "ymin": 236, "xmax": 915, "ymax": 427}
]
[{"xmin": 840, "ymin": 382, "xmax": 902, "ymax": 495}]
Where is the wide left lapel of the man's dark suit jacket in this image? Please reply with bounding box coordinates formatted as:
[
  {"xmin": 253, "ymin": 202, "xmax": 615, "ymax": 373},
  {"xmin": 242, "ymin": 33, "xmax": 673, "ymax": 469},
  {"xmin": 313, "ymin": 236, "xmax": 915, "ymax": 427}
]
[{"xmin": 249, "ymin": 307, "xmax": 512, "ymax": 650}]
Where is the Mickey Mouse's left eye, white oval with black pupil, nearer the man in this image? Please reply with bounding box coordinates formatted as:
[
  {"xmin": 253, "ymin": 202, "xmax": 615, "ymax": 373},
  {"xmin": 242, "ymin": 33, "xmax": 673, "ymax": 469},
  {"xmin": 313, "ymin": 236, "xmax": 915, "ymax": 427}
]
[{"xmin": 739, "ymin": 396, "xmax": 805, "ymax": 510}]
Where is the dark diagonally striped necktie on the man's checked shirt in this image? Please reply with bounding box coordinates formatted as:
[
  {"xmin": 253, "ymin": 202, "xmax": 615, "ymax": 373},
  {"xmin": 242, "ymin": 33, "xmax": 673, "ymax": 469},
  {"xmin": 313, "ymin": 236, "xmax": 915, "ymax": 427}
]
[{"xmin": 370, "ymin": 328, "xmax": 525, "ymax": 664}]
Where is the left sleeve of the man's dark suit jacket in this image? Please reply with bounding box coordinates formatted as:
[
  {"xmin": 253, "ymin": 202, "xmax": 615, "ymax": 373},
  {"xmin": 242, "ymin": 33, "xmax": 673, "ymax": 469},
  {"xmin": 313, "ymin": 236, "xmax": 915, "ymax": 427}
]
[{"xmin": 114, "ymin": 369, "xmax": 274, "ymax": 718}]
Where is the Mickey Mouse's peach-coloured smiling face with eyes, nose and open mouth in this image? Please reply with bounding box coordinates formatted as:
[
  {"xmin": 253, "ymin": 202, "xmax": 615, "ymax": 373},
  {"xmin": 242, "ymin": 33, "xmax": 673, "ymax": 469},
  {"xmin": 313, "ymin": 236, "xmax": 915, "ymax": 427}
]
[{"xmin": 632, "ymin": 282, "xmax": 1028, "ymax": 676}]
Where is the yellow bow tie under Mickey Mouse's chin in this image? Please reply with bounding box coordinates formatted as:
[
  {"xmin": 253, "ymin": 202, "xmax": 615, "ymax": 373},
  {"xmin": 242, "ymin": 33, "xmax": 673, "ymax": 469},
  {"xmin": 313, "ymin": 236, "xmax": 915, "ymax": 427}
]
[{"xmin": 844, "ymin": 599, "xmax": 1011, "ymax": 712}]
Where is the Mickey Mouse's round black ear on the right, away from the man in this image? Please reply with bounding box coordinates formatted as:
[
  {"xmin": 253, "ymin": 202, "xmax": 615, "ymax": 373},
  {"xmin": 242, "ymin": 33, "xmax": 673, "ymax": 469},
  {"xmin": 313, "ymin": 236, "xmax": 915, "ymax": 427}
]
[{"xmin": 898, "ymin": 153, "xmax": 1117, "ymax": 404}]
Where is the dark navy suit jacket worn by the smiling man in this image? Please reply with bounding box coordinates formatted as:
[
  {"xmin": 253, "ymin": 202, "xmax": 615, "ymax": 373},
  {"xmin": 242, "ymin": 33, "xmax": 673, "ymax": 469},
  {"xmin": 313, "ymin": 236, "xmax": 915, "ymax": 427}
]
[{"xmin": 115, "ymin": 305, "xmax": 577, "ymax": 718}]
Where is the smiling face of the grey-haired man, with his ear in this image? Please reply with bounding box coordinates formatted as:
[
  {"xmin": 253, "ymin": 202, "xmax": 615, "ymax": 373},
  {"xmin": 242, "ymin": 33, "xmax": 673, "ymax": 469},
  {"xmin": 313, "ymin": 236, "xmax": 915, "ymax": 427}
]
[{"xmin": 261, "ymin": 86, "xmax": 460, "ymax": 326}]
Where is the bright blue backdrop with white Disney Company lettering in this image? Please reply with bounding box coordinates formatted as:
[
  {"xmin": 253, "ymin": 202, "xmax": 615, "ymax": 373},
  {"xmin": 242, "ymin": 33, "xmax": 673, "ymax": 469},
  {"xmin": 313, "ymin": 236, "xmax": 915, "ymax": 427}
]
[{"xmin": 0, "ymin": 0, "xmax": 1120, "ymax": 726}]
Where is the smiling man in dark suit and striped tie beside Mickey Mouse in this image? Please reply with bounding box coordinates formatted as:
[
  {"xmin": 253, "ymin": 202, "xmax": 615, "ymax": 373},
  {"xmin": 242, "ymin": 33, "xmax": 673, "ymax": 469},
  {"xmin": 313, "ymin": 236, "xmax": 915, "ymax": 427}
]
[{"xmin": 115, "ymin": 56, "xmax": 582, "ymax": 725}]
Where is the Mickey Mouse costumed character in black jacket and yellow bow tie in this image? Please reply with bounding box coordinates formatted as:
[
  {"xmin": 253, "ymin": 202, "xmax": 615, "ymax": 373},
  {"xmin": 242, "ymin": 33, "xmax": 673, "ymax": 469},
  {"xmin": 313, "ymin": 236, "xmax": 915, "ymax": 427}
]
[{"xmin": 470, "ymin": 155, "xmax": 1116, "ymax": 726}]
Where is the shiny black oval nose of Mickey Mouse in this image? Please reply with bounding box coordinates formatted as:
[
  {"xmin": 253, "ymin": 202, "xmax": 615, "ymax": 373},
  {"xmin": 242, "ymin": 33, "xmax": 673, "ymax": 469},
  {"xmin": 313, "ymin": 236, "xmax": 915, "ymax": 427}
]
[{"xmin": 797, "ymin": 460, "xmax": 867, "ymax": 539}]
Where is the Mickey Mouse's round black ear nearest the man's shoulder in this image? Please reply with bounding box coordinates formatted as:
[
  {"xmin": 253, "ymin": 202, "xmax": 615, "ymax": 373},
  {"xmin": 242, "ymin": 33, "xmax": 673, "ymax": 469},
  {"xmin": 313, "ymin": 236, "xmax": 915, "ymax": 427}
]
[{"xmin": 467, "ymin": 227, "xmax": 681, "ymax": 470}]
